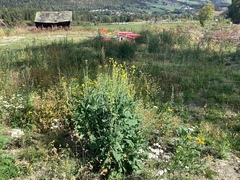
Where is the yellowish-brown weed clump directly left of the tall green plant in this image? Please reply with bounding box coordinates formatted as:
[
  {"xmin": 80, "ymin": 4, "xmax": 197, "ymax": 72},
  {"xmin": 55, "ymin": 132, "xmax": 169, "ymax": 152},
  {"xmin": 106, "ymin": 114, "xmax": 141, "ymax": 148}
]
[{"xmin": 30, "ymin": 77, "xmax": 75, "ymax": 129}]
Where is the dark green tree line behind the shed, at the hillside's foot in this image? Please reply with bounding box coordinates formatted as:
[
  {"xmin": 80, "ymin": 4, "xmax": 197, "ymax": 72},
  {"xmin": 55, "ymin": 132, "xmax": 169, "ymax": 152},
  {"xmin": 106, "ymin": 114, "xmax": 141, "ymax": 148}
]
[{"xmin": 0, "ymin": 8, "xmax": 199, "ymax": 26}]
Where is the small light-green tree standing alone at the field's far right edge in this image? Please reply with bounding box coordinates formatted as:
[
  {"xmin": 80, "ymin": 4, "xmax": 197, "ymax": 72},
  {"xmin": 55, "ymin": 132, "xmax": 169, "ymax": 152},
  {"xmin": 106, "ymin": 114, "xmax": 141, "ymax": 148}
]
[{"xmin": 199, "ymin": 3, "xmax": 215, "ymax": 26}]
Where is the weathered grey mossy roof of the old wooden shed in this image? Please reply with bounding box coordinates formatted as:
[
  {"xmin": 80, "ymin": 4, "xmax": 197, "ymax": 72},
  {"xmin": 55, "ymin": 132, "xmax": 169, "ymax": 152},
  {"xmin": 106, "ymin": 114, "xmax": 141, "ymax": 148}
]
[{"xmin": 34, "ymin": 11, "xmax": 72, "ymax": 23}]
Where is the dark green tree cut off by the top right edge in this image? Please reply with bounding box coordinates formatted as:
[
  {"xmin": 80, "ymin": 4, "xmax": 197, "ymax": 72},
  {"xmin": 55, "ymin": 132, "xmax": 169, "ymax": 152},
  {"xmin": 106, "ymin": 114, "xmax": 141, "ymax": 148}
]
[{"xmin": 228, "ymin": 0, "xmax": 240, "ymax": 23}]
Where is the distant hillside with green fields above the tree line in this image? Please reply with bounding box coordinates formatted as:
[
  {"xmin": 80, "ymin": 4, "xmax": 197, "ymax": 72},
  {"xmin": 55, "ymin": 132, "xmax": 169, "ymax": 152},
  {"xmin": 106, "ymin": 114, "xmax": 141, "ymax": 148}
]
[{"xmin": 0, "ymin": 0, "xmax": 231, "ymax": 13}]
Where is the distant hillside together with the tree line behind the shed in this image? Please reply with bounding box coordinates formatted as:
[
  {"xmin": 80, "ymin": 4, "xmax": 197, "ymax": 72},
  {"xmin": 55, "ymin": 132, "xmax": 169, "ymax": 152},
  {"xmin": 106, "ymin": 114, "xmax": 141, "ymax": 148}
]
[{"xmin": 0, "ymin": 0, "xmax": 232, "ymax": 26}]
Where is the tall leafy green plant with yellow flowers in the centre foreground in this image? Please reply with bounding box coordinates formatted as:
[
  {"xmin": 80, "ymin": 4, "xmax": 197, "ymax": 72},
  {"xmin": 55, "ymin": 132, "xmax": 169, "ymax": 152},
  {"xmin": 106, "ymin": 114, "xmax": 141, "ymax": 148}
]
[{"xmin": 76, "ymin": 59, "xmax": 145, "ymax": 176}]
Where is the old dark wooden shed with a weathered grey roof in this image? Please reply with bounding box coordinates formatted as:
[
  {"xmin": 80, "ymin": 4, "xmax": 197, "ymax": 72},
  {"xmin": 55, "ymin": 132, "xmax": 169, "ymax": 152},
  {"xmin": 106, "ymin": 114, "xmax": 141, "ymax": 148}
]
[{"xmin": 34, "ymin": 11, "xmax": 72, "ymax": 28}]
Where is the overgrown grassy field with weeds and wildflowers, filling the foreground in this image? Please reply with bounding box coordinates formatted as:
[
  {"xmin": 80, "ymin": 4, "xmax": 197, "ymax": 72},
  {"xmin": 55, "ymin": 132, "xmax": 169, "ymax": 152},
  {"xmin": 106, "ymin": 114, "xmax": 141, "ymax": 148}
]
[{"xmin": 0, "ymin": 23, "xmax": 240, "ymax": 179}]
